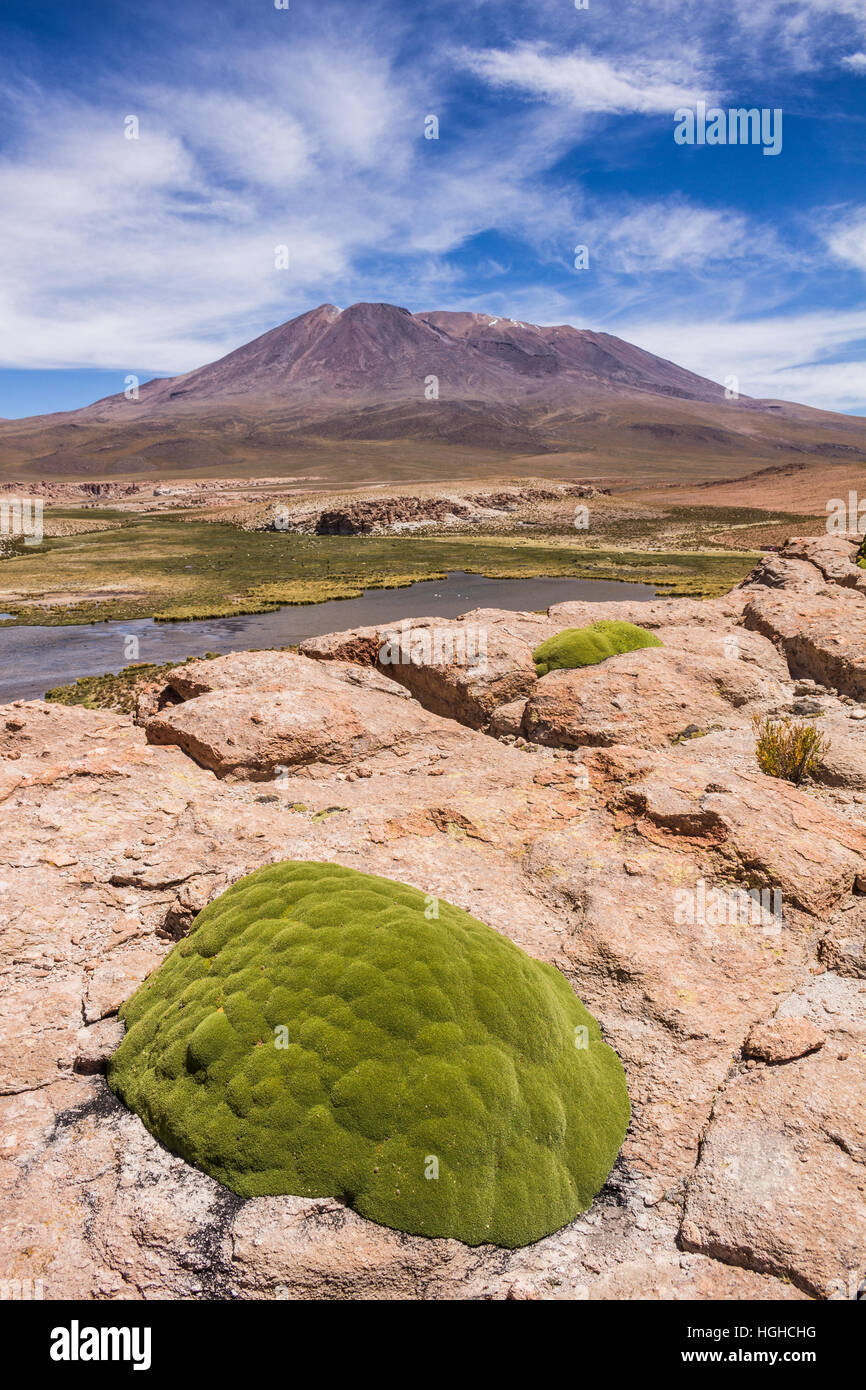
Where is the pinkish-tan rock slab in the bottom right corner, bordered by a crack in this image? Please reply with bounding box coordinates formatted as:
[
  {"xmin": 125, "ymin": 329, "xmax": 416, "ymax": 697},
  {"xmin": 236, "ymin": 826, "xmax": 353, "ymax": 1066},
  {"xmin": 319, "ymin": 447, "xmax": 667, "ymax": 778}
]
[{"xmin": 683, "ymin": 981, "xmax": 866, "ymax": 1298}]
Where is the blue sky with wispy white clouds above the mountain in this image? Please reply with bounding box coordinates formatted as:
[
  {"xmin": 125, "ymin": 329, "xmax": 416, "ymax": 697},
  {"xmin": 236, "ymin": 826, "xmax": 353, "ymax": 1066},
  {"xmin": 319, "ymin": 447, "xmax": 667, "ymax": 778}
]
[{"xmin": 0, "ymin": 0, "xmax": 866, "ymax": 417}]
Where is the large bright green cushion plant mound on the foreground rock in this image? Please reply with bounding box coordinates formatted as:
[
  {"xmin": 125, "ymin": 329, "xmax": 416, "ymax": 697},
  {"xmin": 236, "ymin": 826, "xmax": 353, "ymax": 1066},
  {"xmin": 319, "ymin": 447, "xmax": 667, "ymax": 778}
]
[{"xmin": 108, "ymin": 860, "xmax": 628, "ymax": 1247}]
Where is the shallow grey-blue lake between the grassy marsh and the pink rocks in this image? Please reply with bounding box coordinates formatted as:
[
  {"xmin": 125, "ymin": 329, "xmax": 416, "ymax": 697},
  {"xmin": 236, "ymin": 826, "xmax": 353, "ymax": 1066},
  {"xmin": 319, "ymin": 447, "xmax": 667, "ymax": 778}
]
[{"xmin": 0, "ymin": 570, "xmax": 656, "ymax": 703}]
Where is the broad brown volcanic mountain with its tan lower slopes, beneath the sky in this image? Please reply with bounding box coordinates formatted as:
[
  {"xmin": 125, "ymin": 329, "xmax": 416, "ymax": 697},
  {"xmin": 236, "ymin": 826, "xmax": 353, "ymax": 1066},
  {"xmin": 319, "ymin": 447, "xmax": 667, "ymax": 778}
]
[{"xmin": 0, "ymin": 303, "xmax": 866, "ymax": 482}]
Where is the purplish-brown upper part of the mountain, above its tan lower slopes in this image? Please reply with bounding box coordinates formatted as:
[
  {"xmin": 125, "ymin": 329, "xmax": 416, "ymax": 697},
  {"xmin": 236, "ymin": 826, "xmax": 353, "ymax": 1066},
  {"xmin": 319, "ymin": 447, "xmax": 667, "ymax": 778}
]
[{"xmin": 109, "ymin": 300, "xmax": 739, "ymax": 413}]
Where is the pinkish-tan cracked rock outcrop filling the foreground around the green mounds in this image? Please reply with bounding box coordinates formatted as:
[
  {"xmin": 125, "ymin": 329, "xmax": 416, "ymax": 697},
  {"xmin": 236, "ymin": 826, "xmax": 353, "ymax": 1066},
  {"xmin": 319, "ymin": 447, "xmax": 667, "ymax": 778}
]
[{"xmin": 0, "ymin": 542, "xmax": 866, "ymax": 1300}]
